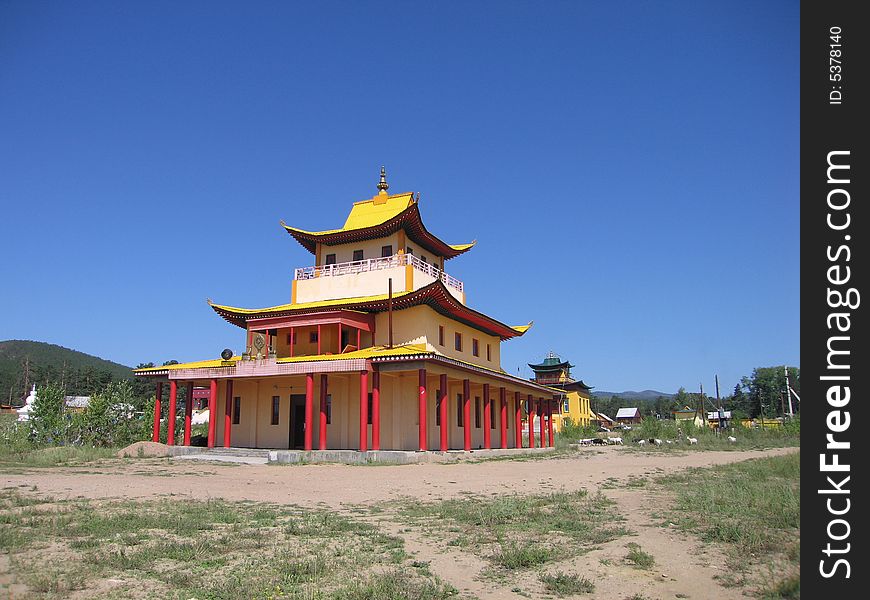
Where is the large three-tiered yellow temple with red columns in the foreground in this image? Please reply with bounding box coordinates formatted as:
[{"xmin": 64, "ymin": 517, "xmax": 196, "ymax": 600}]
[{"xmin": 136, "ymin": 168, "xmax": 558, "ymax": 452}]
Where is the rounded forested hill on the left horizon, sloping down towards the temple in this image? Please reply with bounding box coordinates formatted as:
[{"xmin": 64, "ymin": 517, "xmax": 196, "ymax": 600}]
[{"xmin": 0, "ymin": 340, "xmax": 133, "ymax": 404}]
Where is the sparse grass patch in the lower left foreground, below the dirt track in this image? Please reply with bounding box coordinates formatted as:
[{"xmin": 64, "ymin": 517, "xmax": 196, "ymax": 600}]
[{"xmin": 0, "ymin": 490, "xmax": 454, "ymax": 600}]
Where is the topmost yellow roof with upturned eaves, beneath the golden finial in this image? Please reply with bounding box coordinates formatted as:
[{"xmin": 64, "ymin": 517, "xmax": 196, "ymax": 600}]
[{"xmin": 281, "ymin": 192, "xmax": 476, "ymax": 259}]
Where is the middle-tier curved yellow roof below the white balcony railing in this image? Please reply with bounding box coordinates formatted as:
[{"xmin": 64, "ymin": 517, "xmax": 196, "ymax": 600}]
[{"xmin": 209, "ymin": 280, "xmax": 532, "ymax": 340}]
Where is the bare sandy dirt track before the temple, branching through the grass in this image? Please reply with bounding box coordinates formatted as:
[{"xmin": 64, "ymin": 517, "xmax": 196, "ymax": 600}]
[{"xmin": 0, "ymin": 447, "xmax": 797, "ymax": 600}]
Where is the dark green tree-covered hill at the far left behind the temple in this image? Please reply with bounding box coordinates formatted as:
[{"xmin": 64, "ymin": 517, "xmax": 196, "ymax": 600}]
[{"xmin": 0, "ymin": 340, "xmax": 133, "ymax": 402}]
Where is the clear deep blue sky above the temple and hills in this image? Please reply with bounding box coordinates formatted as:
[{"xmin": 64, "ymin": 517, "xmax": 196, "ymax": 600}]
[{"xmin": 0, "ymin": 1, "xmax": 800, "ymax": 392}]
